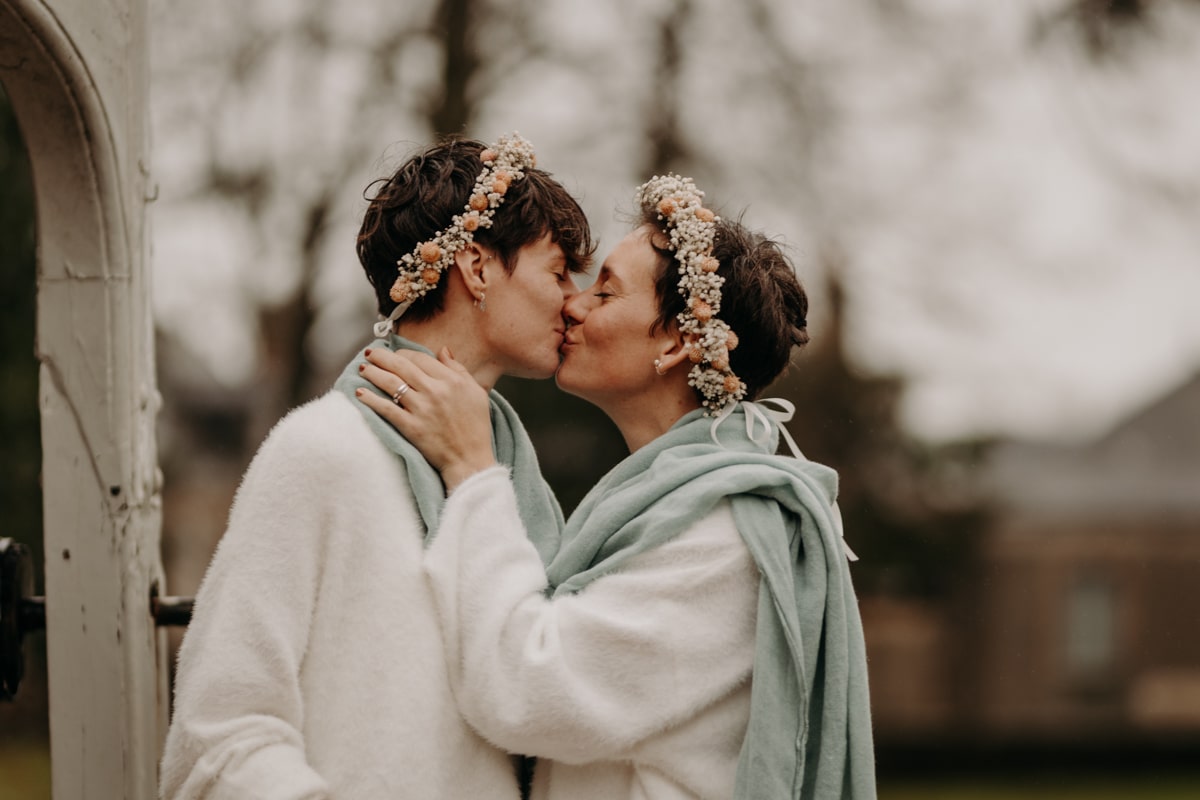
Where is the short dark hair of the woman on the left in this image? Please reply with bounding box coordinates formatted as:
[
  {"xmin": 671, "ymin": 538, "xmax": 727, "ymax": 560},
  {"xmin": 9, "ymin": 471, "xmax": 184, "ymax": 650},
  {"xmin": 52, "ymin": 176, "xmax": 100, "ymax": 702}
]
[{"xmin": 356, "ymin": 138, "xmax": 595, "ymax": 319}]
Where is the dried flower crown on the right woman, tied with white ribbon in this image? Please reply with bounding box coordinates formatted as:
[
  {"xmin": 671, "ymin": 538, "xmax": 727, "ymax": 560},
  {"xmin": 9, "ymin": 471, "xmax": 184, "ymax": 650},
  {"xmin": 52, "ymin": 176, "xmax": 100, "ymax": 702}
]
[{"xmin": 637, "ymin": 174, "xmax": 745, "ymax": 416}]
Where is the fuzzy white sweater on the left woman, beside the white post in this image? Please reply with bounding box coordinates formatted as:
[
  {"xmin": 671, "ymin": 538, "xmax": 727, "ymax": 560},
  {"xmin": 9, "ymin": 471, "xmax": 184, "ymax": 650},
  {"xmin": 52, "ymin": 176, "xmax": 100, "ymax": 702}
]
[{"xmin": 161, "ymin": 392, "xmax": 517, "ymax": 800}]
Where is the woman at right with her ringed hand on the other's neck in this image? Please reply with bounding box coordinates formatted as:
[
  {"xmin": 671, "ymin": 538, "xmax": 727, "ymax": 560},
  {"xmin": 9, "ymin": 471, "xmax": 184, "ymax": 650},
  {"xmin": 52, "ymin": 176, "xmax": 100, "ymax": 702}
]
[{"xmin": 360, "ymin": 175, "xmax": 875, "ymax": 800}]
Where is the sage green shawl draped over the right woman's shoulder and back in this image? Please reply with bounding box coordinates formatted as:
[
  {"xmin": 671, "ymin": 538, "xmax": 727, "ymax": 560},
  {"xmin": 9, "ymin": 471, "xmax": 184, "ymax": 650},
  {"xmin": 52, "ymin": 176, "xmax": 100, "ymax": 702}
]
[{"xmin": 546, "ymin": 403, "xmax": 875, "ymax": 800}]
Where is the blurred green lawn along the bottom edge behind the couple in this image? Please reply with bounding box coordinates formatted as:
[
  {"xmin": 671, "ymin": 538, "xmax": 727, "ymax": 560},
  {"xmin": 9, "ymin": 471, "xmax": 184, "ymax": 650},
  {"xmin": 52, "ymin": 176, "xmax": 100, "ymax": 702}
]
[{"xmin": 0, "ymin": 741, "xmax": 1200, "ymax": 800}]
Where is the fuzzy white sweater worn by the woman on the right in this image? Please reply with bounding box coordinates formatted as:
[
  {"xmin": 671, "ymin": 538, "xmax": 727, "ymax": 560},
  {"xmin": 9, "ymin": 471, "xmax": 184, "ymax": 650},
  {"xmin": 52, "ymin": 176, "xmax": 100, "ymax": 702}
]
[{"xmin": 425, "ymin": 468, "xmax": 758, "ymax": 800}]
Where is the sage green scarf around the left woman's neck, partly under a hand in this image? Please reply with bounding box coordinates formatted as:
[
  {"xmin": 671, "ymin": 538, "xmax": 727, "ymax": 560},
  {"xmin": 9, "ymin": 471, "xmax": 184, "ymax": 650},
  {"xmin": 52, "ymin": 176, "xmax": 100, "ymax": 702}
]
[{"xmin": 334, "ymin": 333, "xmax": 563, "ymax": 563}]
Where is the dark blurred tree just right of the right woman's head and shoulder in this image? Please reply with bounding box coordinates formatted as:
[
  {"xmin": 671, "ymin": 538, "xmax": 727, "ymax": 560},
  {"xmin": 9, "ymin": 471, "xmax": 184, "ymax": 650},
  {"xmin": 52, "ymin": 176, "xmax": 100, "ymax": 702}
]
[{"xmin": 768, "ymin": 268, "xmax": 989, "ymax": 602}]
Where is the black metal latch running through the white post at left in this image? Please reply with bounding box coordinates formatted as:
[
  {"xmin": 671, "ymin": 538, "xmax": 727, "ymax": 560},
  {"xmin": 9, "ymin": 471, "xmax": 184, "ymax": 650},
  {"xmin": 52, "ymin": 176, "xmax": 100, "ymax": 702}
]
[{"xmin": 0, "ymin": 539, "xmax": 192, "ymax": 700}]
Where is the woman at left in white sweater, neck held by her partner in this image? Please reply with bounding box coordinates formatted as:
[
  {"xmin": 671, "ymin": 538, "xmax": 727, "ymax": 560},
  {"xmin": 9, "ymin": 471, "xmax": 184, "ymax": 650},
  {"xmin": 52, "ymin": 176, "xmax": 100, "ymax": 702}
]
[{"xmin": 161, "ymin": 136, "xmax": 592, "ymax": 800}]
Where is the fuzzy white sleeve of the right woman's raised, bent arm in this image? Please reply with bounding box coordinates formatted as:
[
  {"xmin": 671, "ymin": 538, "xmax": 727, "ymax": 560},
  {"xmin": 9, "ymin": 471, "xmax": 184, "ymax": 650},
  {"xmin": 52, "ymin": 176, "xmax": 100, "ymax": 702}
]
[{"xmin": 426, "ymin": 470, "xmax": 756, "ymax": 762}]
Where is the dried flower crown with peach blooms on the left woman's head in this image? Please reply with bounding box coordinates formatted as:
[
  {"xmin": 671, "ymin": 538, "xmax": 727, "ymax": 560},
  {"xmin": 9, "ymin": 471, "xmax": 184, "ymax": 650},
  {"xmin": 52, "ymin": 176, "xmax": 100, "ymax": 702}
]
[{"xmin": 389, "ymin": 132, "xmax": 538, "ymax": 309}]
